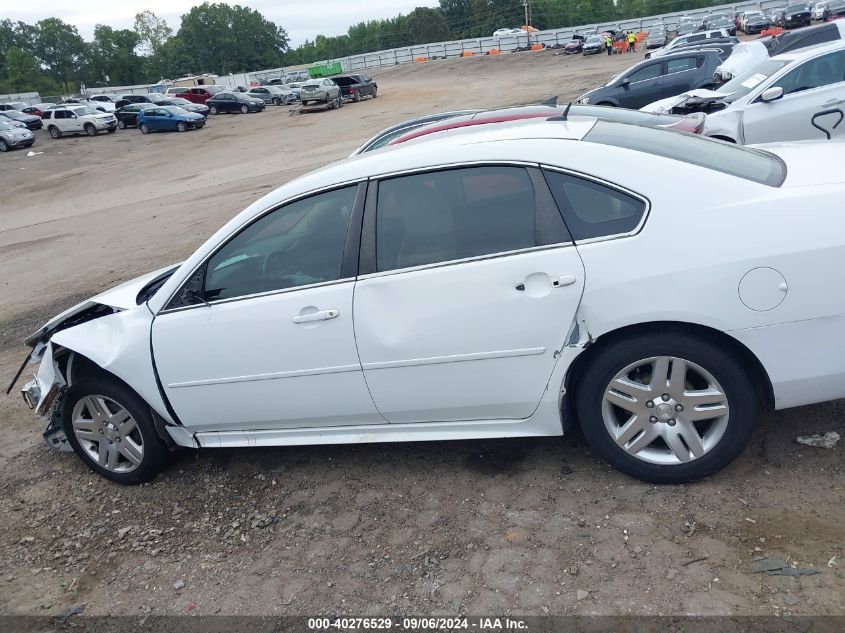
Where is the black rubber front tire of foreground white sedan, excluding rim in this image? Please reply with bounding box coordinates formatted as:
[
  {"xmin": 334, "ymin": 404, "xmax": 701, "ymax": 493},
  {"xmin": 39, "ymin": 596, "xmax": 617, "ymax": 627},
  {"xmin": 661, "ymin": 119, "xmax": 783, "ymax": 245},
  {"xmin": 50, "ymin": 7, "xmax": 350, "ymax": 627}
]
[{"xmin": 62, "ymin": 377, "xmax": 168, "ymax": 484}]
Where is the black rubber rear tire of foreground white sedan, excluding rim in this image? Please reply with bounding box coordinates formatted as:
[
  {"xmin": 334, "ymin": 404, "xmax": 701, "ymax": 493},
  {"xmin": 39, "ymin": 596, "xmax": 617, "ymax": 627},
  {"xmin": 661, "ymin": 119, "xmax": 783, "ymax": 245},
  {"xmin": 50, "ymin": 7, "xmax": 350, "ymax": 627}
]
[{"xmin": 575, "ymin": 333, "xmax": 757, "ymax": 483}]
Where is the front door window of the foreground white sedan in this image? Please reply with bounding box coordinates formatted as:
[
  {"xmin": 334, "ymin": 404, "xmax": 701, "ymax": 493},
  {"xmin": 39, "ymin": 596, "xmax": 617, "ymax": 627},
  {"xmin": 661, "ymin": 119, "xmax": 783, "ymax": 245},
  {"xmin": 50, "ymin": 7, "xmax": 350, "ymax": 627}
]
[{"xmin": 202, "ymin": 185, "xmax": 358, "ymax": 301}]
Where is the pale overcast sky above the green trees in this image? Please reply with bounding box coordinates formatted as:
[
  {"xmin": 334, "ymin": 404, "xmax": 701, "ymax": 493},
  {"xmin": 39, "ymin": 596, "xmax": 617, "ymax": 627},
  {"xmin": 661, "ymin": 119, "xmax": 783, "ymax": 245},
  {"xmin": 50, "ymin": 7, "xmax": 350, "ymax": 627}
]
[{"xmin": 0, "ymin": 0, "xmax": 438, "ymax": 46}]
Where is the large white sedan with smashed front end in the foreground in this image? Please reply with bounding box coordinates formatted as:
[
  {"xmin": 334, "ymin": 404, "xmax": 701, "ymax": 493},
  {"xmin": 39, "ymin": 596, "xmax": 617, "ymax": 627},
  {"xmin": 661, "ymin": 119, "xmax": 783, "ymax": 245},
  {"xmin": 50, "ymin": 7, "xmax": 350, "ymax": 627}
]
[{"xmin": 13, "ymin": 116, "xmax": 845, "ymax": 483}]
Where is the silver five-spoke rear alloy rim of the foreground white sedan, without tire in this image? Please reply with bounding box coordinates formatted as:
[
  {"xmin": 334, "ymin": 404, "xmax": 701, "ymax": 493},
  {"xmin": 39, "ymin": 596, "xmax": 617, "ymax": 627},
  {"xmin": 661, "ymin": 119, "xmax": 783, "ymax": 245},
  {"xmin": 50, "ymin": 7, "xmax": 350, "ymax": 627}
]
[{"xmin": 602, "ymin": 356, "xmax": 729, "ymax": 465}]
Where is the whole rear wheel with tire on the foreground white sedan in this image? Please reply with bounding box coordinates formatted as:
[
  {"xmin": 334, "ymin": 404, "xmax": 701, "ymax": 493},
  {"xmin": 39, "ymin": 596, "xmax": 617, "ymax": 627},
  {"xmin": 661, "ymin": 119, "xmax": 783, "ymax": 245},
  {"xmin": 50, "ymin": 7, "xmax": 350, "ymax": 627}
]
[{"xmin": 575, "ymin": 330, "xmax": 757, "ymax": 483}]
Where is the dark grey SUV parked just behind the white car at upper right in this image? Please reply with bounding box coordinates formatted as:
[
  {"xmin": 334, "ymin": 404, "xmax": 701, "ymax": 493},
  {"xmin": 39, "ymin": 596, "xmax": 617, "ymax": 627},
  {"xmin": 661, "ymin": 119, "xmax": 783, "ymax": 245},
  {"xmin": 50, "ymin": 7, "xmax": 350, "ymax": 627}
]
[{"xmin": 578, "ymin": 50, "xmax": 722, "ymax": 108}]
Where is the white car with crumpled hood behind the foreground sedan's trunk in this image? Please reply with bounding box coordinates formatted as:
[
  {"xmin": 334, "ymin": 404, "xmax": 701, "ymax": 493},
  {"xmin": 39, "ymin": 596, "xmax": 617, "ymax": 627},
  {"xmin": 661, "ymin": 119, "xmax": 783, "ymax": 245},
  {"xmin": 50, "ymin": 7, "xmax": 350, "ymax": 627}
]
[{"xmin": 642, "ymin": 40, "xmax": 845, "ymax": 144}]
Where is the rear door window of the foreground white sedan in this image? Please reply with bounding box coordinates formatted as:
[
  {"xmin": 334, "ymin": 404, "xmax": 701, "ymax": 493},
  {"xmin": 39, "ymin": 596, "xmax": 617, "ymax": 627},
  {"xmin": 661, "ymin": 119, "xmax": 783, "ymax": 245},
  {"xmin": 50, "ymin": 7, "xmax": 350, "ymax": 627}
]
[{"xmin": 376, "ymin": 167, "xmax": 538, "ymax": 271}]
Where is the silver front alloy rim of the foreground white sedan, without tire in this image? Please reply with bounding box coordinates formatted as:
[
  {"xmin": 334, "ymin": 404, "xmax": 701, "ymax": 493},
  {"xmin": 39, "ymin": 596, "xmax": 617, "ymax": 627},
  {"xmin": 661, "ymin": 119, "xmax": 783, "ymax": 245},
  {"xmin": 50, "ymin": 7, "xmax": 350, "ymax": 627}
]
[{"xmin": 72, "ymin": 394, "xmax": 144, "ymax": 473}]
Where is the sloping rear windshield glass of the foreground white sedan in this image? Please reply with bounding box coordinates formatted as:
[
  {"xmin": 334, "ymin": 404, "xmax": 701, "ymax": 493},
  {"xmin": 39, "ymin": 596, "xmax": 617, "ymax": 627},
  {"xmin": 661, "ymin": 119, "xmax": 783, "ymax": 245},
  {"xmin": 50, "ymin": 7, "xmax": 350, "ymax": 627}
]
[{"xmin": 582, "ymin": 120, "xmax": 786, "ymax": 187}]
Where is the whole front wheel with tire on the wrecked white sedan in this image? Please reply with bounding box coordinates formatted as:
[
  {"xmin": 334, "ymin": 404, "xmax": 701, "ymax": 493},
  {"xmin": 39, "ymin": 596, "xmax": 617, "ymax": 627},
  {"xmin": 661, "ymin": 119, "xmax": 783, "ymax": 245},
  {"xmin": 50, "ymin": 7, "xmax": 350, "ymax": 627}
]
[{"xmin": 62, "ymin": 376, "xmax": 168, "ymax": 484}]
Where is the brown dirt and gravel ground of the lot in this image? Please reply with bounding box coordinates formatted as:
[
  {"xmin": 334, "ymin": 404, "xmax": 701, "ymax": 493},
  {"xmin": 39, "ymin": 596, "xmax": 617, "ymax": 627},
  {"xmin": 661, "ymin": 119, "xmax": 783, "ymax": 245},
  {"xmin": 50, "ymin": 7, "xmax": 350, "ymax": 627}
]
[{"xmin": 0, "ymin": 52, "xmax": 845, "ymax": 615}]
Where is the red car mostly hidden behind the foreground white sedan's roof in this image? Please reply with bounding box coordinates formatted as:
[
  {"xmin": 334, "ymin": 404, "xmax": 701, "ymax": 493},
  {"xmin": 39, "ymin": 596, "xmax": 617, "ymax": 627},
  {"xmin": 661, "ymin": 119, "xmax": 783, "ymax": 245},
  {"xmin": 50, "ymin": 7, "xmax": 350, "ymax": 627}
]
[{"xmin": 390, "ymin": 105, "xmax": 705, "ymax": 145}]
